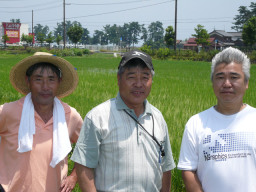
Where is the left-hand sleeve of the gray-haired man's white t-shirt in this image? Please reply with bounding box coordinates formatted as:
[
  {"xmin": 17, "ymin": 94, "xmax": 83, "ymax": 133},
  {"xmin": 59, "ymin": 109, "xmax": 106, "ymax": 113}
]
[{"xmin": 177, "ymin": 121, "xmax": 198, "ymax": 171}]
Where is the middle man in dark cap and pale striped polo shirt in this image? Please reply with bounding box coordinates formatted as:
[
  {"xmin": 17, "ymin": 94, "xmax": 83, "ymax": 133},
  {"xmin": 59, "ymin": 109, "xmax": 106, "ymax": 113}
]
[{"xmin": 71, "ymin": 51, "xmax": 175, "ymax": 192}]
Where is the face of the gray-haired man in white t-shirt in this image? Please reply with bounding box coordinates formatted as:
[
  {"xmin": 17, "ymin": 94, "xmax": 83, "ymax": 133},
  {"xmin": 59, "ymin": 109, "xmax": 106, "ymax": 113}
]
[{"xmin": 212, "ymin": 62, "xmax": 248, "ymax": 106}]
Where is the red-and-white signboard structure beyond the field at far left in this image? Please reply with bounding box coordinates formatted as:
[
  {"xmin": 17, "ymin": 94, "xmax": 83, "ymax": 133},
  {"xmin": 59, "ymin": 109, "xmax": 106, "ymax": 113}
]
[{"xmin": 0, "ymin": 22, "xmax": 29, "ymax": 44}]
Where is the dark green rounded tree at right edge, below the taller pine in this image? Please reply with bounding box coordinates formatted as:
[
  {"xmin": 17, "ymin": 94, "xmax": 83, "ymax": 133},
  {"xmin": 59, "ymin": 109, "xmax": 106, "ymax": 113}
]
[{"xmin": 242, "ymin": 17, "xmax": 256, "ymax": 46}]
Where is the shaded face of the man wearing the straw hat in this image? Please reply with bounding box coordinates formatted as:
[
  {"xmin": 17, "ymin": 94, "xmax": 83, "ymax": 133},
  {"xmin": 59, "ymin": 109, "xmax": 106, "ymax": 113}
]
[{"xmin": 27, "ymin": 68, "xmax": 60, "ymax": 105}]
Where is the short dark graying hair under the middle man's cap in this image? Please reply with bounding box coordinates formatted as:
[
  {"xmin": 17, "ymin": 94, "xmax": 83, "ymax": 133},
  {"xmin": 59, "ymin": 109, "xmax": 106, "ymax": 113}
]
[{"xmin": 117, "ymin": 58, "xmax": 155, "ymax": 77}]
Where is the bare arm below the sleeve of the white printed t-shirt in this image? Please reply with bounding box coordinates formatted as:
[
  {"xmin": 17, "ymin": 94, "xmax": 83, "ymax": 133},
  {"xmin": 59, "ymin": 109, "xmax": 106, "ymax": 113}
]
[{"xmin": 182, "ymin": 170, "xmax": 203, "ymax": 192}]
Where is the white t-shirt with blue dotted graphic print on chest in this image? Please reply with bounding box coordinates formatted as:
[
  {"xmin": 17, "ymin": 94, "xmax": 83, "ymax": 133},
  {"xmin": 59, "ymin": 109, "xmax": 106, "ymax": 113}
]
[{"xmin": 178, "ymin": 105, "xmax": 256, "ymax": 192}]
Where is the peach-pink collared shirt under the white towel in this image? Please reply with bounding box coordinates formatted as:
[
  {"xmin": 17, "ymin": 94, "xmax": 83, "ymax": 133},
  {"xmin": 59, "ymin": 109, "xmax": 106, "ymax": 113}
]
[{"xmin": 0, "ymin": 97, "xmax": 83, "ymax": 192}]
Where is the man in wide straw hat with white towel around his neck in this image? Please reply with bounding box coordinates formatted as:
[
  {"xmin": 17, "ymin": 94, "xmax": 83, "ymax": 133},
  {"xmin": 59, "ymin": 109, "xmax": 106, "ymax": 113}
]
[{"xmin": 0, "ymin": 53, "xmax": 82, "ymax": 192}]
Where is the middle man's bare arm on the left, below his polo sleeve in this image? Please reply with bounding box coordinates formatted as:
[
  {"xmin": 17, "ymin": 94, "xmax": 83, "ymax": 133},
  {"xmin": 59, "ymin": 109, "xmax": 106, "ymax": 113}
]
[{"xmin": 75, "ymin": 163, "xmax": 97, "ymax": 192}]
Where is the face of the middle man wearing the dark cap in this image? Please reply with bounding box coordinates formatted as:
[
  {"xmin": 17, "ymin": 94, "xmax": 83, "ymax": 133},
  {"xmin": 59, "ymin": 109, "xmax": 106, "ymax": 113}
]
[{"xmin": 118, "ymin": 67, "xmax": 152, "ymax": 109}]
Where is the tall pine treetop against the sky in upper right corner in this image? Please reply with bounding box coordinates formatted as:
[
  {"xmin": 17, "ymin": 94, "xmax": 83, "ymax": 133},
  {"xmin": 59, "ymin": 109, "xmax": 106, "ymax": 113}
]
[{"xmin": 231, "ymin": 2, "xmax": 256, "ymax": 31}]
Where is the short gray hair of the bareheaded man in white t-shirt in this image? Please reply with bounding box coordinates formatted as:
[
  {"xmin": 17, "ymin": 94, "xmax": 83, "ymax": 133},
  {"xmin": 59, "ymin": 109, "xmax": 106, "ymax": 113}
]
[{"xmin": 211, "ymin": 47, "xmax": 251, "ymax": 82}]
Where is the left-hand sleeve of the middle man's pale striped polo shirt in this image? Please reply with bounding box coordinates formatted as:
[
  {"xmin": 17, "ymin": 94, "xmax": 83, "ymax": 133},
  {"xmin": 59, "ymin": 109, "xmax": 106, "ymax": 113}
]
[{"xmin": 71, "ymin": 116, "xmax": 100, "ymax": 168}]
